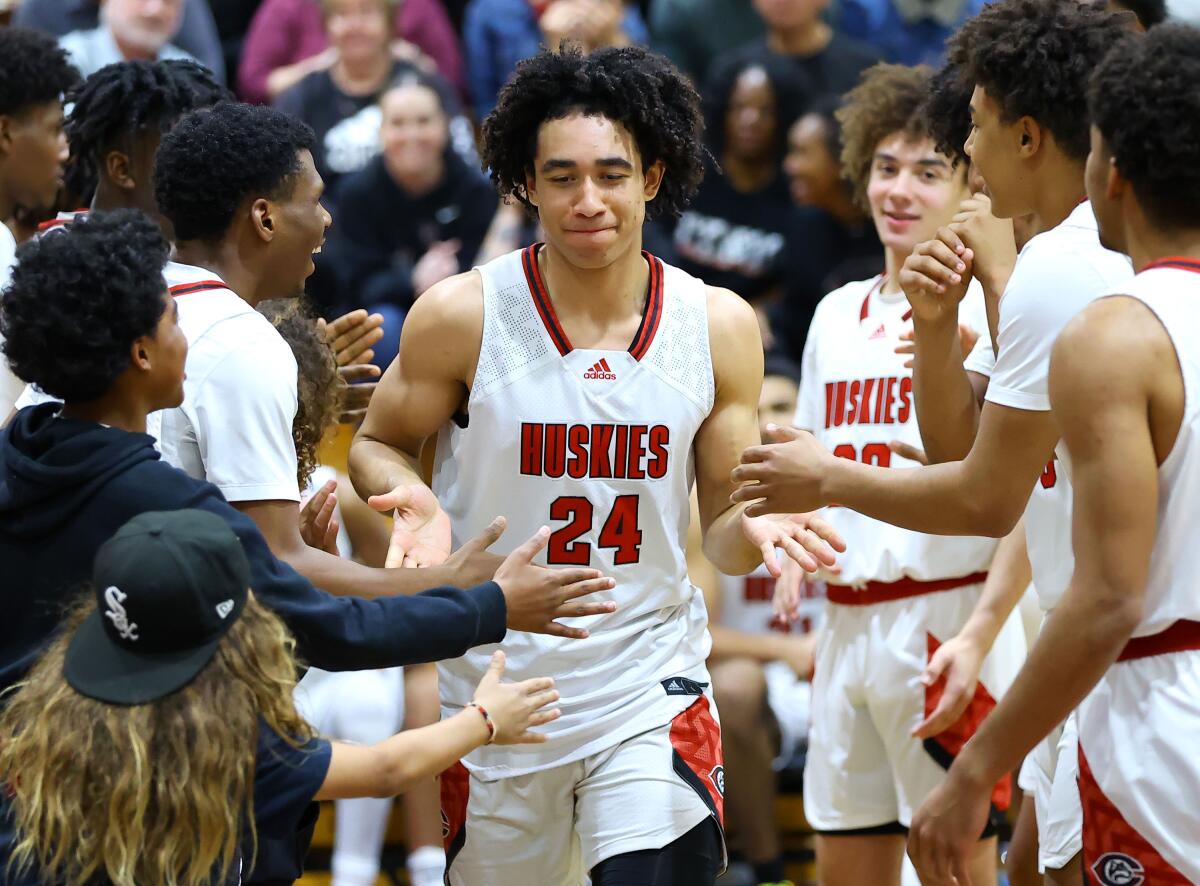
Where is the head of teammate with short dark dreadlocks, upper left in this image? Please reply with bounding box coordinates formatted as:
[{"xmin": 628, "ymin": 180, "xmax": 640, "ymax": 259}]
[{"xmin": 66, "ymin": 59, "xmax": 233, "ymax": 224}]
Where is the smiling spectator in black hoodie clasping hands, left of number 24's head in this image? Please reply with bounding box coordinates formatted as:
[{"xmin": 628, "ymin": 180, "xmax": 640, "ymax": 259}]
[{"xmin": 326, "ymin": 73, "xmax": 499, "ymax": 369}]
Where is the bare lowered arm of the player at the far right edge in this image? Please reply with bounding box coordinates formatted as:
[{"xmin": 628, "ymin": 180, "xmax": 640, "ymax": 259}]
[{"xmin": 910, "ymin": 299, "xmax": 1161, "ymax": 882}]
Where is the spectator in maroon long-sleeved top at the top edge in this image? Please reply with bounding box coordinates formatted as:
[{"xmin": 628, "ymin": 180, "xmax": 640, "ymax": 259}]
[{"xmin": 238, "ymin": 0, "xmax": 466, "ymax": 102}]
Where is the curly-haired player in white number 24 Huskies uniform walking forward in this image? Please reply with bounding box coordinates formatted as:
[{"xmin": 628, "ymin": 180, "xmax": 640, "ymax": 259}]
[{"xmin": 350, "ymin": 48, "xmax": 840, "ymax": 886}]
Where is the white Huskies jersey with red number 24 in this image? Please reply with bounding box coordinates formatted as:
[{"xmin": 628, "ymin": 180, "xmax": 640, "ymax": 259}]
[{"xmin": 433, "ymin": 246, "xmax": 714, "ymax": 778}]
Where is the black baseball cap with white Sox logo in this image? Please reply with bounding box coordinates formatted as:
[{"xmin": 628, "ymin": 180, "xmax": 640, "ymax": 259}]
[{"xmin": 62, "ymin": 510, "xmax": 250, "ymax": 705}]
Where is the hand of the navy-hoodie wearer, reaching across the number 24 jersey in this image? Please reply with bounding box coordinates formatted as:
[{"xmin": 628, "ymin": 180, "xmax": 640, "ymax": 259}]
[{"xmin": 494, "ymin": 526, "xmax": 617, "ymax": 640}]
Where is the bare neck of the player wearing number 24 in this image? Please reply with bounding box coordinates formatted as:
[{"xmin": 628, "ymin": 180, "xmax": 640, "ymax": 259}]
[{"xmin": 538, "ymin": 238, "xmax": 650, "ymax": 323}]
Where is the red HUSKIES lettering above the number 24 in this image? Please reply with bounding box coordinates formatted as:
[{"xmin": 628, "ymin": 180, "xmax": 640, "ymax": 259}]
[{"xmin": 521, "ymin": 421, "xmax": 671, "ymax": 480}]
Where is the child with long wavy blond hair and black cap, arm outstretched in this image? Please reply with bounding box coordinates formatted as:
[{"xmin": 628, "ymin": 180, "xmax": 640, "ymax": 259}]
[{"xmin": 0, "ymin": 509, "xmax": 558, "ymax": 886}]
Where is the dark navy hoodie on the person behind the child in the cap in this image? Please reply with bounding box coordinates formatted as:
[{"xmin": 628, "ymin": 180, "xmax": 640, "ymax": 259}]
[{"xmin": 0, "ymin": 403, "xmax": 506, "ymax": 884}]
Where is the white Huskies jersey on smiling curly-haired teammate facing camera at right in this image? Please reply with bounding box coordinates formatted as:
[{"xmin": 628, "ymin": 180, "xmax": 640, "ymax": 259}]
[{"xmin": 796, "ymin": 277, "xmax": 996, "ymax": 585}]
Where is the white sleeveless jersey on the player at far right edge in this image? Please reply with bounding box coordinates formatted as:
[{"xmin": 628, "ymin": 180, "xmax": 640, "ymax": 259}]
[{"xmin": 1058, "ymin": 258, "xmax": 1200, "ymax": 636}]
